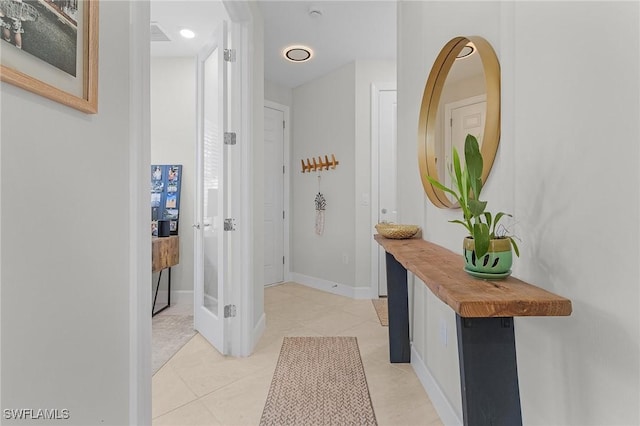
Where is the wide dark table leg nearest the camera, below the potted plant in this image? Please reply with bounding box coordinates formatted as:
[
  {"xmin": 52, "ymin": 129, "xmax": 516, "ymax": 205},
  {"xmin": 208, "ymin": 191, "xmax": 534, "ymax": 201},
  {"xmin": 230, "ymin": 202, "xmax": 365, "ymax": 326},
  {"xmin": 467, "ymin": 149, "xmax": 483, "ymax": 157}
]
[{"xmin": 456, "ymin": 314, "xmax": 522, "ymax": 426}]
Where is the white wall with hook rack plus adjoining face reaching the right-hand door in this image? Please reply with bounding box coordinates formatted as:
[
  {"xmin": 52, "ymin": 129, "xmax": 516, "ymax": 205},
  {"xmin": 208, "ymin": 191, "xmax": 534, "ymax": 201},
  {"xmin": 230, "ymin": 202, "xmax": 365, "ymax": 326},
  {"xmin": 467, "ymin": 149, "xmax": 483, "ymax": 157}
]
[{"xmin": 291, "ymin": 61, "xmax": 396, "ymax": 297}]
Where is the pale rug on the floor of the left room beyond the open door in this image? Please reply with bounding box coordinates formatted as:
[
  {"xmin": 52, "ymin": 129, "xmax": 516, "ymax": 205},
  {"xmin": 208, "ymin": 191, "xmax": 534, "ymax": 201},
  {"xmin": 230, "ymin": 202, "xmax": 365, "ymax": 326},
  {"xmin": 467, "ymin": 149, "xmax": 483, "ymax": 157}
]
[{"xmin": 151, "ymin": 314, "xmax": 196, "ymax": 374}]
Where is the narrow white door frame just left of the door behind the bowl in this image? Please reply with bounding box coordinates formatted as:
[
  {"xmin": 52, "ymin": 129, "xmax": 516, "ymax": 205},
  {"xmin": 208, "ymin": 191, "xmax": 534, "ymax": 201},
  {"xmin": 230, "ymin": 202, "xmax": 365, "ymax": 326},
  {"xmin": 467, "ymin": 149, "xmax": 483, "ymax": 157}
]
[{"xmin": 370, "ymin": 82, "xmax": 397, "ymax": 299}]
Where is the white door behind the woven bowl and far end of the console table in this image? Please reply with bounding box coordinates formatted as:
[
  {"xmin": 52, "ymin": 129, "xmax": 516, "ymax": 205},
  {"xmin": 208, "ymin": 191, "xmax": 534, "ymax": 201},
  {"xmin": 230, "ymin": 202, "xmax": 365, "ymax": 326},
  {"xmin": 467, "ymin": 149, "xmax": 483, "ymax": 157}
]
[{"xmin": 371, "ymin": 83, "xmax": 398, "ymax": 296}]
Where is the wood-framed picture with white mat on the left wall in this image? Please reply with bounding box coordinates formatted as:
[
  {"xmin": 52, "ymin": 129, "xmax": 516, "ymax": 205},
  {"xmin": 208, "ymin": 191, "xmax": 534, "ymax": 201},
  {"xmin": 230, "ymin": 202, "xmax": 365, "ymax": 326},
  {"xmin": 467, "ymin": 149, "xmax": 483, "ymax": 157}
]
[{"xmin": 0, "ymin": 0, "xmax": 98, "ymax": 114}]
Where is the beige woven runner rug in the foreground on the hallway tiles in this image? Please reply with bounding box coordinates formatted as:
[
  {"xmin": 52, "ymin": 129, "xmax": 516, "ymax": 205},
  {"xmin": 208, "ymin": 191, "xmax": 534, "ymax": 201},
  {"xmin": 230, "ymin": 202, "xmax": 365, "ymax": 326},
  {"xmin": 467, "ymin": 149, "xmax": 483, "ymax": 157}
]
[{"xmin": 260, "ymin": 337, "xmax": 377, "ymax": 426}]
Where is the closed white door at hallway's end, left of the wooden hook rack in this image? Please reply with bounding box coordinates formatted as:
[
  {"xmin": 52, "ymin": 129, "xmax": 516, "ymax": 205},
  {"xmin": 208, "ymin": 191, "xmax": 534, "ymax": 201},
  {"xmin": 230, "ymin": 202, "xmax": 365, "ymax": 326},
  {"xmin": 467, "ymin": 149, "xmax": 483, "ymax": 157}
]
[{"xmin": 264, "ymin": 106, "xmax": 284, "ymax": 285}]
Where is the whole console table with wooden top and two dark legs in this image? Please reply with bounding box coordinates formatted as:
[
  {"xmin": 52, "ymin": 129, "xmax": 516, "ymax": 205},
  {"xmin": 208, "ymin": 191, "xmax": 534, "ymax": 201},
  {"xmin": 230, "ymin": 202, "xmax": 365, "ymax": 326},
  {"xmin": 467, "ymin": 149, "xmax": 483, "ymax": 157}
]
[{"xmin": 374, "ymin": 234, "xmax": 571, "ymax": 426}]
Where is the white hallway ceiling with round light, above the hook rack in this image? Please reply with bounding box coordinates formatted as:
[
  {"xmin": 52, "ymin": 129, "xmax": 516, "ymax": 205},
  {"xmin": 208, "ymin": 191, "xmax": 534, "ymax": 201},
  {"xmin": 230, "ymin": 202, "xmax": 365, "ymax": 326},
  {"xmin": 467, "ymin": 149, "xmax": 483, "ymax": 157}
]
[{"xmin": 259, "ymin": 0, "xmax": 396, "ymax": 87}]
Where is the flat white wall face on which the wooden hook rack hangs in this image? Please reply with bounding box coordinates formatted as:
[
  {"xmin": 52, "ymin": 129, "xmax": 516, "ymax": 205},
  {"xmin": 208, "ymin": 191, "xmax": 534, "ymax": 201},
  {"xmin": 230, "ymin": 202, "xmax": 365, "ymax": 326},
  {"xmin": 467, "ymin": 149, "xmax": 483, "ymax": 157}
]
[{"xmin": 291, "ymin": 63, "xmax": 355, "ymax": 286}]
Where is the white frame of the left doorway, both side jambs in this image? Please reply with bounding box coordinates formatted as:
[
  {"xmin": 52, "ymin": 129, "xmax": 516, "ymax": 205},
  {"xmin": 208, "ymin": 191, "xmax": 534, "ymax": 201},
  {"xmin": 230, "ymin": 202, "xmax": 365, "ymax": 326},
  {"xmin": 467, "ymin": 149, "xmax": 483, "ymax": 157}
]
[{"xmin": 129, "ymin": 0, "xmax": 254, "ymax": 425}]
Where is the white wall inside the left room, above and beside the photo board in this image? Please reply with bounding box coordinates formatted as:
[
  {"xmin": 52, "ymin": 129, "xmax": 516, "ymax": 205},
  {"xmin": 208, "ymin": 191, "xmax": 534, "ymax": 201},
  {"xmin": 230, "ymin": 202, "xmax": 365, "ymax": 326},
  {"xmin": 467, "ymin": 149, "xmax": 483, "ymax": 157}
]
[{"xmin": 151, "ymin": 57, "xmax": 196, "ymax": 298}]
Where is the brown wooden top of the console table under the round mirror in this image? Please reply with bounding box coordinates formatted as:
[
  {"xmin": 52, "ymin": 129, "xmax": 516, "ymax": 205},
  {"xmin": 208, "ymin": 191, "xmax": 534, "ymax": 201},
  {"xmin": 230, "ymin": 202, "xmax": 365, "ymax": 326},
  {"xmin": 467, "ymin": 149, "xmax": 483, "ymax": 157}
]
[{"xmin": 374, "ymin": 234, "xmax": 571, "ymax": 318}]
